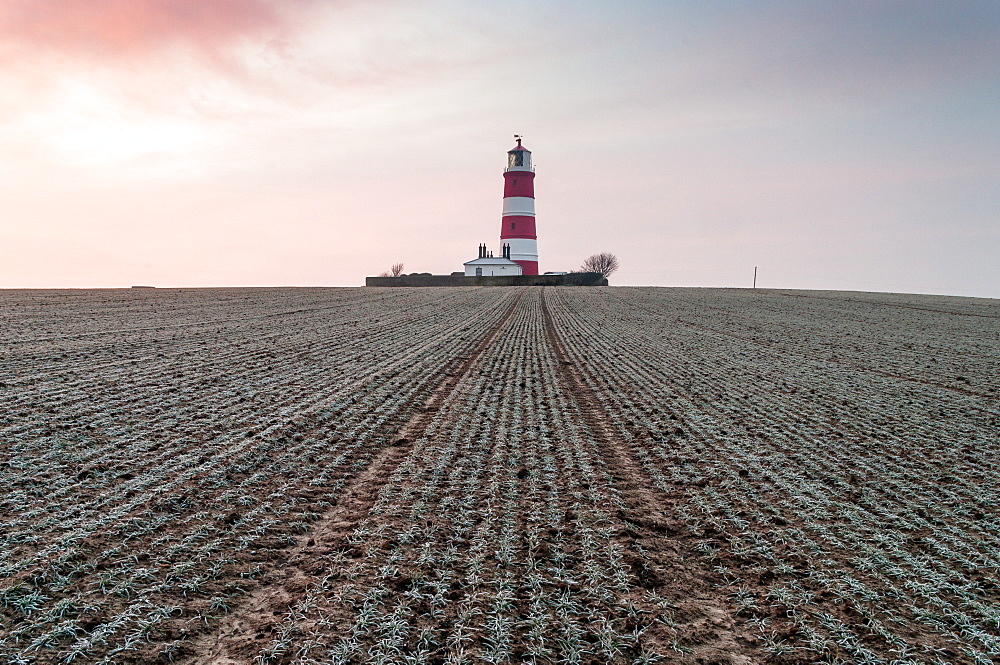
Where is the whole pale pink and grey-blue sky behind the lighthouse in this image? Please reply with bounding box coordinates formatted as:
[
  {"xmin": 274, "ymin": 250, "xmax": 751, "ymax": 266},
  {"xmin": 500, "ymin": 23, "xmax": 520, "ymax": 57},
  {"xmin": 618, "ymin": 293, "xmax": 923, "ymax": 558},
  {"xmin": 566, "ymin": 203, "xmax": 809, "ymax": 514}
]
[{"xmin": 0, "ymin": 0, "xmax": 1000, "ymax": 298}]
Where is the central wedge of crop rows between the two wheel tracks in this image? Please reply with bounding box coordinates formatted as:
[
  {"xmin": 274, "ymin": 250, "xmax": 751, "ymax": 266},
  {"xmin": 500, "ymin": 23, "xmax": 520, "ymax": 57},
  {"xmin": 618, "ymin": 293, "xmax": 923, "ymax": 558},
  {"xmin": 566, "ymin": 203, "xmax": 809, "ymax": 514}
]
[{"xmin": 195, "ymin": 289, "xmax": 732, "ymax": 663}]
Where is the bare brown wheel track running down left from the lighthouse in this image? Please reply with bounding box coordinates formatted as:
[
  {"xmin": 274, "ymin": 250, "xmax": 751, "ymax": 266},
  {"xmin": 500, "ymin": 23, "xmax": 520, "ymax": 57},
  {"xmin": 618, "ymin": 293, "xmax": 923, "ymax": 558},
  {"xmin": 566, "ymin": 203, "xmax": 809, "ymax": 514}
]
[{"xmin": 188, "ymin": 289, "xmax": 525, "ymax": 665}]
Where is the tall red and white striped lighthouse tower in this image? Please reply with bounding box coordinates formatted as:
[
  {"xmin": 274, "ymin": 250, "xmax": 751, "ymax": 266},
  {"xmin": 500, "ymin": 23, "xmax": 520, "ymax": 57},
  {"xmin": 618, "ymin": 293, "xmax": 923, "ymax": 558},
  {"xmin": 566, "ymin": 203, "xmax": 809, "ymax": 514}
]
[{"xmin": 500, "ymin": 135, "xmax": 538, "ymax": 275}]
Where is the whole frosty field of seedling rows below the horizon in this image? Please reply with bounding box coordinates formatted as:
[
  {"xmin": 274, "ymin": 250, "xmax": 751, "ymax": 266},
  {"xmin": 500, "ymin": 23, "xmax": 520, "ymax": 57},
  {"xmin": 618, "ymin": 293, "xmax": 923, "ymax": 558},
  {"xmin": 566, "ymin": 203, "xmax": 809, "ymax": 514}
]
[{"xmin": 0, "ymin": 287, "xmax": 1000, "ymax": 664}]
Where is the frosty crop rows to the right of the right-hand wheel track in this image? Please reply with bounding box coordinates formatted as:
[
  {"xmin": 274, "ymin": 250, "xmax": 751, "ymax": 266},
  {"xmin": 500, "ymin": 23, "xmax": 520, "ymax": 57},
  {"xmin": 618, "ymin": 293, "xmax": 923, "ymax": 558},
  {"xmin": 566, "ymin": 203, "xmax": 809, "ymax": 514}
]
[{"xmin": 549, "ymin": 290, "xmax": 1000, "ymax": 663}]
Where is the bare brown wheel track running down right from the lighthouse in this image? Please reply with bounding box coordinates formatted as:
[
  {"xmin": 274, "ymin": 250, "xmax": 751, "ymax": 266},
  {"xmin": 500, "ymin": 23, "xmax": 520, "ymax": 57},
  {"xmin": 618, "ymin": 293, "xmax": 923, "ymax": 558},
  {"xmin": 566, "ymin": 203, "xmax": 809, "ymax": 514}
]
[{"xmin": 541, "ymin": 288, "xmax": 765, "ymax": 665}]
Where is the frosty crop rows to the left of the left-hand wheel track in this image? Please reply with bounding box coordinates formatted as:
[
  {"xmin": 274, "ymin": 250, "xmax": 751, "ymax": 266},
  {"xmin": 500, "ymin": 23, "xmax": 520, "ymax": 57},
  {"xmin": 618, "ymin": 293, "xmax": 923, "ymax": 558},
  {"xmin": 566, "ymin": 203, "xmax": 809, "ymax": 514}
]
[{"xmin": 0, "ymin": 290, "xmax": 513, "ymax": 662}]
